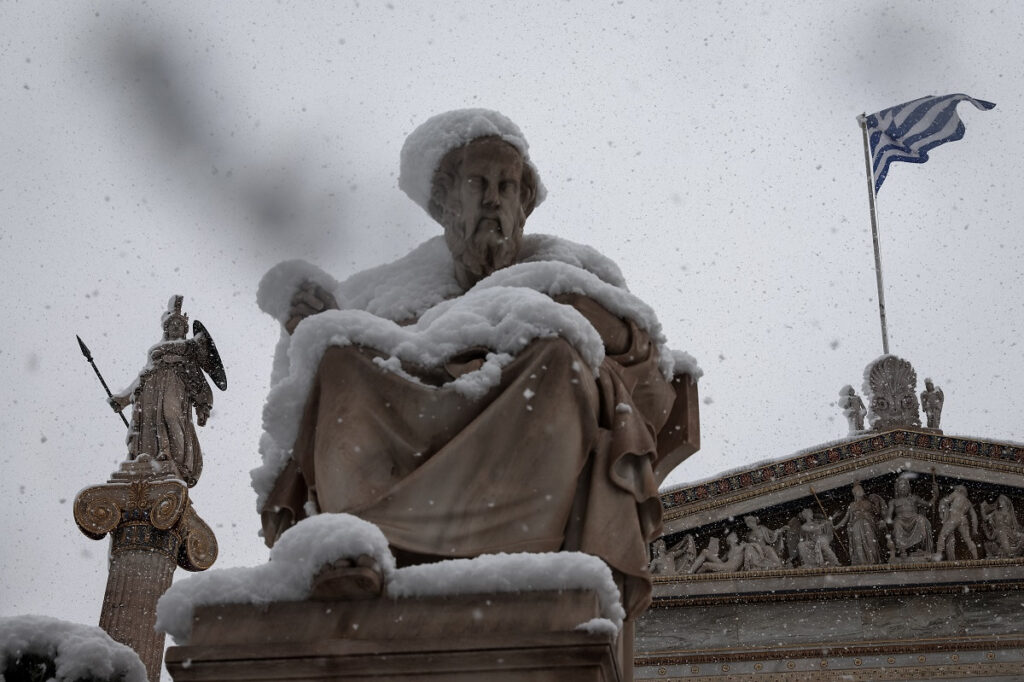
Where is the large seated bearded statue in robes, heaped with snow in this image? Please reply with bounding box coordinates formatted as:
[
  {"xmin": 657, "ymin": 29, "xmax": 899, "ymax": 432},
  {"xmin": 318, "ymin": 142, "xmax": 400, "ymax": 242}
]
[{"xmin": 253, "ymin": 110, "xmax": 699, "ymax": 614}]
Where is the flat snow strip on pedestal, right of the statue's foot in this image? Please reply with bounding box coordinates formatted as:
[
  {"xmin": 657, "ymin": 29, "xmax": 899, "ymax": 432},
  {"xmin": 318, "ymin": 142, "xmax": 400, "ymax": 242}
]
[{"xmin": 387, "ymin": 552, "xmax": 626, "ymax": 631}]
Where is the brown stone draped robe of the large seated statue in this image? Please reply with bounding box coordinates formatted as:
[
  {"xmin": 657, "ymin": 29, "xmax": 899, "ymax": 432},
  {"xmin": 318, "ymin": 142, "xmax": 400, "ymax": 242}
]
[{"xmin": 262, "ymin": 236, "xmax": 697, "ymax": 615}]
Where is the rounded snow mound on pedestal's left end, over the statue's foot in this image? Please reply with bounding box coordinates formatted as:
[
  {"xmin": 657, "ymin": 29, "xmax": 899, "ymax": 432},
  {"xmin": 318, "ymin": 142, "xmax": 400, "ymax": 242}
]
[{"xmin": 156, "ymin": 514, "xmax": 394, "ymax": 644}]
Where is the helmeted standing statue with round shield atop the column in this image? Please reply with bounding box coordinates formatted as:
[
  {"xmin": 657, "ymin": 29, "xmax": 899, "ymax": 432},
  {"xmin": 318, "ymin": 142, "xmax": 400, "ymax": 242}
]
[{"xmin": 110, "ymin": 296, "xmax": 227, "ymax": 487}]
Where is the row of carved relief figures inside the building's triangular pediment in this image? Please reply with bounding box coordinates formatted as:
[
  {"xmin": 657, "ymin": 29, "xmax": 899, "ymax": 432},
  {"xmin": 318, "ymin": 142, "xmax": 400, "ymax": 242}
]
[{"xmin": 650, "ymin": 464, "xmax": 1024, "ymax": 576}]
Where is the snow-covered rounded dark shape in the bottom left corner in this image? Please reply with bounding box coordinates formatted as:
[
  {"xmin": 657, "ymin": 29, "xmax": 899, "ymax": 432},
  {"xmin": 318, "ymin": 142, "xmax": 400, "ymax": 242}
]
[{"xmin": 0, "ymin": 615, "xmax": 147, "ymax": 682}]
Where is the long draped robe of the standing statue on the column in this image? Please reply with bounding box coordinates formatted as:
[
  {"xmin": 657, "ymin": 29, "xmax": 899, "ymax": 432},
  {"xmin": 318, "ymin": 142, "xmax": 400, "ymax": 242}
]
[{"xmin": 128, "ymin": 341, "xmax": 213, "ymax": 485}]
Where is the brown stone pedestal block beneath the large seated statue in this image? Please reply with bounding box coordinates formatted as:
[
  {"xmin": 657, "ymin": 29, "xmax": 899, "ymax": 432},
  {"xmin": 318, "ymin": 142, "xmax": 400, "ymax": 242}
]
[{"xmin": 167, "ymin": 590, "xmax": 632, "ymax": 682}]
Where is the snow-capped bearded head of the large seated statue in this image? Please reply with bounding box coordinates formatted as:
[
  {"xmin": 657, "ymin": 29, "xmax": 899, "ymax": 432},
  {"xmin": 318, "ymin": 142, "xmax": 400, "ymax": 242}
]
[{"xmin": 398, "ymin": 109, "xmax": 546, "ymax": 286}]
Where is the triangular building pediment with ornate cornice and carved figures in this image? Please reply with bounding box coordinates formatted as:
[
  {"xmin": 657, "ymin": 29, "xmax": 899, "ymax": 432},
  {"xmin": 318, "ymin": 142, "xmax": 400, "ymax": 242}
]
[{"xmin": 651, "ymin": 428, "xmax": 1024, "ymax": 599}]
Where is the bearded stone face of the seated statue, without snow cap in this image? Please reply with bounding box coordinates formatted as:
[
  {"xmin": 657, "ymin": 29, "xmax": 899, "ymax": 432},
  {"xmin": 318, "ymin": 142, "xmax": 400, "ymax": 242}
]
[{"xmin": 441, "ymin": 137, "xmax": 532, "ymax": 280}]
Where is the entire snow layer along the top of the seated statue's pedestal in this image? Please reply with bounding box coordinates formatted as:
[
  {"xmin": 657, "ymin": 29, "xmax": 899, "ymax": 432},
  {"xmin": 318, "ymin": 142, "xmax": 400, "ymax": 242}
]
[{"xmin": 157, "ymin": 514, "xmax": 625, "ymax": 644}]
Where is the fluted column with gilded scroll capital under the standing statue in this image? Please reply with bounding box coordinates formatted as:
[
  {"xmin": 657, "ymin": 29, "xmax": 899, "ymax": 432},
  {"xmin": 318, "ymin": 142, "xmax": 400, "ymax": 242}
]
[{"xmin": 75, "ymin": 456, "xmax": 217, "ymax": 682}]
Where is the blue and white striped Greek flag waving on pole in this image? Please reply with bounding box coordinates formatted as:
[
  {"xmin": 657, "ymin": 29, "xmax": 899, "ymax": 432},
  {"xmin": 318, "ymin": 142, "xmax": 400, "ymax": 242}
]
[{"xmin": 866, "ymin": 94, "xmax": 995, "ymax": 193}]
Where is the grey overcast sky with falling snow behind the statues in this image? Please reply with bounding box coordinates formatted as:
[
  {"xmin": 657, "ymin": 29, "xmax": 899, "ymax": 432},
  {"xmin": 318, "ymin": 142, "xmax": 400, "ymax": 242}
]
[{"xmin": 0, "ymin": 0, "xmax": 1024, "ymax": 647}]
